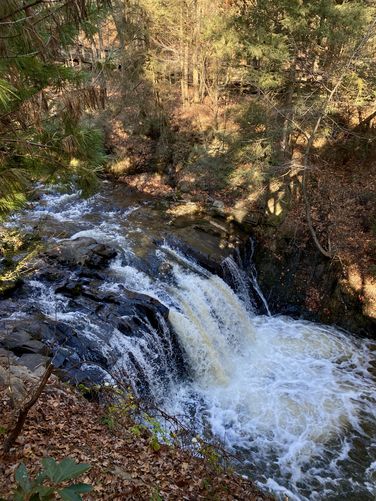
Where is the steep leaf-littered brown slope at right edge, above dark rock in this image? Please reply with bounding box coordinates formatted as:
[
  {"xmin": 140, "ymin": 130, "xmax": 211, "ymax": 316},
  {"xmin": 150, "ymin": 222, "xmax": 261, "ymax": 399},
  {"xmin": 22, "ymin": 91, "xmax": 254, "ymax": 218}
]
[{"xmin": 280, "ymin": 163, "xmax": 376, "ymax": 319}]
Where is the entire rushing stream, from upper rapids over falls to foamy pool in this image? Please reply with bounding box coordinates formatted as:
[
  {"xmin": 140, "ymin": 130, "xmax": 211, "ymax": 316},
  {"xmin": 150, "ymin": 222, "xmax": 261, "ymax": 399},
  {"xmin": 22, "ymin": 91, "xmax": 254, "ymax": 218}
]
[{"xmin": 2, "ymin": 185, "xmax": 376, "ymax": 501}]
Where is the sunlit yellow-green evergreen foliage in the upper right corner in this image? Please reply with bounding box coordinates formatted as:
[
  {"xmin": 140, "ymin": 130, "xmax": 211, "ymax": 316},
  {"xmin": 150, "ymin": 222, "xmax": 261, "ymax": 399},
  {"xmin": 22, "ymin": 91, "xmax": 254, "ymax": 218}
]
[{"xmin": 233, "ymin": 0, "xmax": 375, "ymax": 162}]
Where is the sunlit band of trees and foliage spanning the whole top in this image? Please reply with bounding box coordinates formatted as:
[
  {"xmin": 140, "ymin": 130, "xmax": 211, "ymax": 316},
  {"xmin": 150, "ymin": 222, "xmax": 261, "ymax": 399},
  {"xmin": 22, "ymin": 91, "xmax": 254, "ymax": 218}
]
[{"xmin": 0, "ymin": 0, "xmax": 376, "ymax": 218}]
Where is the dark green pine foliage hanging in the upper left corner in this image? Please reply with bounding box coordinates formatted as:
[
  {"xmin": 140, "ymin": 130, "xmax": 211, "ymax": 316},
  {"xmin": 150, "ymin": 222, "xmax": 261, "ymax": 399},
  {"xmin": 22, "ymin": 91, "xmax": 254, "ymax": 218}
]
[{"xmin": 0, "ymin": 0, "xmax": 107, "ymax": 212}]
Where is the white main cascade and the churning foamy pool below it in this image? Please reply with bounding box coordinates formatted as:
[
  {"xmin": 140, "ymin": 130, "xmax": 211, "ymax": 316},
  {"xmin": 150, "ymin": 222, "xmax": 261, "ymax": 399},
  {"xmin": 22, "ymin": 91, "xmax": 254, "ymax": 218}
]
[{"xmin": 161, "ymin": 268, "xmax": 376, "ymax": 497}]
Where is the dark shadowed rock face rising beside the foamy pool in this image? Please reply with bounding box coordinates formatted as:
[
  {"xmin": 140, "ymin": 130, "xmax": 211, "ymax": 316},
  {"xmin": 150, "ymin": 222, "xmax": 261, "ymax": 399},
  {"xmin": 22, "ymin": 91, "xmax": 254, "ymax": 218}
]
[{"xmin": 254, "ymin": 235, "xmax": 376, "ymax": 338}]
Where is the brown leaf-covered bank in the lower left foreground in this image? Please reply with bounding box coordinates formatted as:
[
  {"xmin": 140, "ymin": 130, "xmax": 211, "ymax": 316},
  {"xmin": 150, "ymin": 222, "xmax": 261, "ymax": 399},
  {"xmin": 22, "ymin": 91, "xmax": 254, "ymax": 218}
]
[{"xmin": 0, "ymin": 376, "xmax": 271, "ymax": 501}]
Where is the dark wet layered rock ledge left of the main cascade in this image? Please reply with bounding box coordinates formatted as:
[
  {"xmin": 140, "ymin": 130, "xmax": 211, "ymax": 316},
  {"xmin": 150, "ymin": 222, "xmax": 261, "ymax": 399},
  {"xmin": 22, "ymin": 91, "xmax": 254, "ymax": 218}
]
[{"xmin": 0, "ymin": 237, "xmax": 183, "ymax": 385}]
